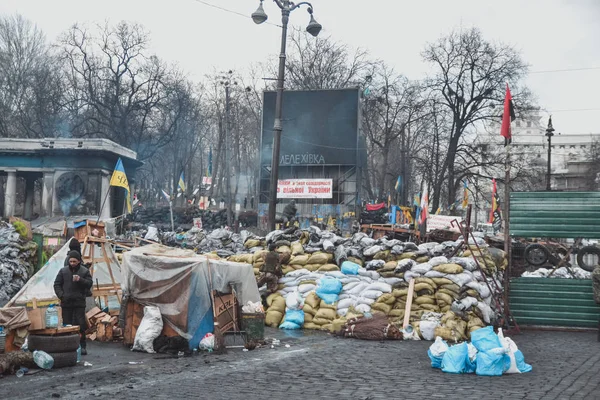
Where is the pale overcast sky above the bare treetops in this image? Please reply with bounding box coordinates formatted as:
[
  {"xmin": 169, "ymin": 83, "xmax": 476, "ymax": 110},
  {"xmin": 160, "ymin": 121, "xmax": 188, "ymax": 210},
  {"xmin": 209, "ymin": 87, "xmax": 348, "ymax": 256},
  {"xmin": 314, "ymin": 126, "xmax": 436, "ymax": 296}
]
[{"xmin": 0, "ymin": 0, "xmax": 600, "ymax": 134}]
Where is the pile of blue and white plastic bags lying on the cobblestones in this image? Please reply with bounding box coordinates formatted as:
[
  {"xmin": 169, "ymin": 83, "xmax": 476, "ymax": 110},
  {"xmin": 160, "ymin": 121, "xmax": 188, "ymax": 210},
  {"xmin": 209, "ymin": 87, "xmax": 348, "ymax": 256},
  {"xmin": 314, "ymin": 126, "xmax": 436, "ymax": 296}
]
[{"xmin": 427, "ymin": 326, "xmax": 532, "ymax": 376}]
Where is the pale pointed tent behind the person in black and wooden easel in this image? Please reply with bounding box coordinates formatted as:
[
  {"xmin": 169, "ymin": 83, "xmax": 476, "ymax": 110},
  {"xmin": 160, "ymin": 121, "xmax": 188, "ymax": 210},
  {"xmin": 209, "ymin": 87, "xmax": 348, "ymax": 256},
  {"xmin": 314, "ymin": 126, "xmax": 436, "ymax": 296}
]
[{"xmin": 7, "ymin": 241, "xmax": 121, "ymax": 309}]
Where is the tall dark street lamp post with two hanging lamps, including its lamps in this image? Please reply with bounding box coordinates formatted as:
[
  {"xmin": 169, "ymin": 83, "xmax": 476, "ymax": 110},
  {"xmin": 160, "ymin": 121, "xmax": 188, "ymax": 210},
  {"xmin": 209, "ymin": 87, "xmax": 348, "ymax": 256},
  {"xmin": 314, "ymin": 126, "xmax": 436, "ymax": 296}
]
[{"xmin": 252, "ymin": 0, "xmax": 322, "ymax": 230}]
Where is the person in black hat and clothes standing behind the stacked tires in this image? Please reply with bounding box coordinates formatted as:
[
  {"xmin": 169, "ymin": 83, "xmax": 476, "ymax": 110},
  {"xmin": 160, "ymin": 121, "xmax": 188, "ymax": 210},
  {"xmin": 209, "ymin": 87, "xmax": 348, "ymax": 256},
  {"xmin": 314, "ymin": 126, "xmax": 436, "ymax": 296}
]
[{"xmin": 54, "ymin": 250, "xmax": 93, "ymax": 355}]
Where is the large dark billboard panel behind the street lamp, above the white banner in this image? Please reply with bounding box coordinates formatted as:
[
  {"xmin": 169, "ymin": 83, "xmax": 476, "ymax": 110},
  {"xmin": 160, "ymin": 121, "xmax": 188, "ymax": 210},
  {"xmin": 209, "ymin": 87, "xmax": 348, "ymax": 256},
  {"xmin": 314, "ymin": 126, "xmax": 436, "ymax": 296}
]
[{"xmin": 261, "ymin": 89, "xmax": 360, "ymax": 166}]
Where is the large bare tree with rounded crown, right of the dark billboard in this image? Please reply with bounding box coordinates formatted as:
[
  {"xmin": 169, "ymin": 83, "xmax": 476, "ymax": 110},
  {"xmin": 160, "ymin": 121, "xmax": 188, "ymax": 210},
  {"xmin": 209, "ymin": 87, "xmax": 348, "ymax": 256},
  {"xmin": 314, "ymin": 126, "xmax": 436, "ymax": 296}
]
[{"xmin": 423, "ymin": 28, "xmax": 528, "ymax": 204}]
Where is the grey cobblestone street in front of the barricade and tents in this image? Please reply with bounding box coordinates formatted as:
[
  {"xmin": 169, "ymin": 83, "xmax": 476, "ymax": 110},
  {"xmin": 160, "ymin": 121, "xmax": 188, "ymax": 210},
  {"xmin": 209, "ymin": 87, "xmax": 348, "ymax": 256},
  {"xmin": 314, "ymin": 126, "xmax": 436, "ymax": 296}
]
[{"xmin": 0, "ymin": 329, "xmax": 600, "ymax": 400}]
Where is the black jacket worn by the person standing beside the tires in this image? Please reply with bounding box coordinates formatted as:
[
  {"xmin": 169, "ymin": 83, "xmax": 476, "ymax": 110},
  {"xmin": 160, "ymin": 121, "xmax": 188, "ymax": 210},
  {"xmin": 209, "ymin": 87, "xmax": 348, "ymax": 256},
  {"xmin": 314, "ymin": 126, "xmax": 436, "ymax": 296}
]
[{"xmin": 54, "ymin": 264, "xmax": 93, "ymax": 307}]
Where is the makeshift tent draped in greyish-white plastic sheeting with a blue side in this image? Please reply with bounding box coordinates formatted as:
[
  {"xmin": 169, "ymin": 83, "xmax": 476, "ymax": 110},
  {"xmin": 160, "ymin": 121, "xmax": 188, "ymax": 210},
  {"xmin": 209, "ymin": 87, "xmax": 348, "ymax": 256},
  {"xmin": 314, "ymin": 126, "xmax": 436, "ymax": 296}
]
[{"xmin": 121, "ymin": 244, "xmax": 260, "ymax": 348}]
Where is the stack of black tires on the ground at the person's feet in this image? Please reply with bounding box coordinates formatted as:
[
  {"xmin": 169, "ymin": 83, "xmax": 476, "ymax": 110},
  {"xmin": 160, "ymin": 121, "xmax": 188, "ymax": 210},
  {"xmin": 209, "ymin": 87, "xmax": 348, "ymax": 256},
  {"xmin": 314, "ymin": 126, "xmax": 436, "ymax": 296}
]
[{"xmin": 27, "ymin": 334, "xmax": 79, "ymax": 368}]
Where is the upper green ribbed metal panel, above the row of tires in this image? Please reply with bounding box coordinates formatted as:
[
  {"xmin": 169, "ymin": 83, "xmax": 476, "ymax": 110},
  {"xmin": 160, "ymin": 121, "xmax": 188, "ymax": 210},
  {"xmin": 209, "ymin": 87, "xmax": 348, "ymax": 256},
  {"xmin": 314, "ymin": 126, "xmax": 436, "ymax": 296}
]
[{"xmin": 510, "ymin": 192, "xmax": 600, "ymax": 239}]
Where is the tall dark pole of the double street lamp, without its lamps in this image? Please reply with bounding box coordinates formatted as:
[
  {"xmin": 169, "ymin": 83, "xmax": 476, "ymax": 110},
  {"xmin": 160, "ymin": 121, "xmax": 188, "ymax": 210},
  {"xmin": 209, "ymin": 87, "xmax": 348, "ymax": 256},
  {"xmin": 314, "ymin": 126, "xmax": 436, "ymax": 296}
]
[{"xmin": 269, "ymin": 7, "xmax": 290, "ymax": 230}]
